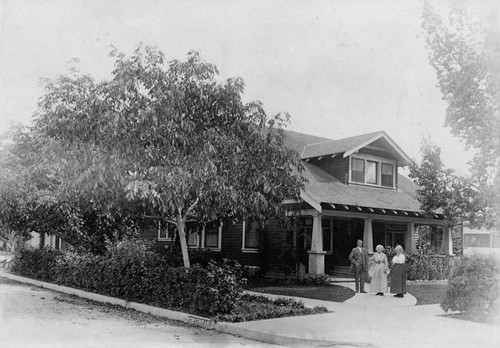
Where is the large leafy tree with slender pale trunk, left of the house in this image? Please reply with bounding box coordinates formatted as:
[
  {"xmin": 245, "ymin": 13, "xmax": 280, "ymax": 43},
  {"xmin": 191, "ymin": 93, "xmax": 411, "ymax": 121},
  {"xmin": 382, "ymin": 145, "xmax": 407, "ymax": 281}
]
[{"xmin": 34, "ymin": 46, "xmax": 303, "ymax": 267}]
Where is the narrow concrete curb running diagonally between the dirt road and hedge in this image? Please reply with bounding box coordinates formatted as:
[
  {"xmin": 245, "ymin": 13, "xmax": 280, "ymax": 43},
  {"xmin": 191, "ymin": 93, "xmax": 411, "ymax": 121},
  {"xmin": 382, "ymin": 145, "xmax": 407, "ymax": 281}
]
[{"xmin": 0, "ymin": 271, "xmax": 356, "ymax": 347}]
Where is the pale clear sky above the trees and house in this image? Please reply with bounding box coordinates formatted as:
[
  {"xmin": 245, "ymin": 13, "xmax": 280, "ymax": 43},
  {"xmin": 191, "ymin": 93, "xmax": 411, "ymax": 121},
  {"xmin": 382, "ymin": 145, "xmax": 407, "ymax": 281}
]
[{"xmin": 0, "ymin": 0, "xmax": 492, "ymax": 175}]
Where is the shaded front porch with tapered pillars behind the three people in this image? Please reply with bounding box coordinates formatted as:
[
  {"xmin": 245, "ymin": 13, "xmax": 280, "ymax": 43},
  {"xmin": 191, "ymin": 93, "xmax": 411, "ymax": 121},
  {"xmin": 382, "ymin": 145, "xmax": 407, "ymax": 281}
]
[{"xmin": 289, "ymin": 204, "xmax": 452, "ymax": 274}]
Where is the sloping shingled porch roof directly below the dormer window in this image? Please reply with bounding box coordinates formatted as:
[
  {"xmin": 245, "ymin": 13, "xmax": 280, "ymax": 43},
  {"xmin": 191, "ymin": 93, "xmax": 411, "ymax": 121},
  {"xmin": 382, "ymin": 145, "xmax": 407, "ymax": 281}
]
[{"xmin": 303, "ymin": 163, "xmax": 421, "ymax": 212}]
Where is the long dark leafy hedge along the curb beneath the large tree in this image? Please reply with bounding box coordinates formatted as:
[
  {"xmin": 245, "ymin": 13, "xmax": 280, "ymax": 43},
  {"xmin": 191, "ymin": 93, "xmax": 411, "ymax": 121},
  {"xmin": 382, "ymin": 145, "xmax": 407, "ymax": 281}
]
[{"xmin": 11, "ymin": 242, "xmax": 243, "ymax": 316}]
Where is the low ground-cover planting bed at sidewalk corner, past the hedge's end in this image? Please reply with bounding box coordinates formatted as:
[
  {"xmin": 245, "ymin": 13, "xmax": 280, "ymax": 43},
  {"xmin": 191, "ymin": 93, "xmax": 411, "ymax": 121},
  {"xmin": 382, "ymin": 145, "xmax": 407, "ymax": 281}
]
[{"xmin": 215, "ymin": 294, "xmax": 327, "ymax": 323}]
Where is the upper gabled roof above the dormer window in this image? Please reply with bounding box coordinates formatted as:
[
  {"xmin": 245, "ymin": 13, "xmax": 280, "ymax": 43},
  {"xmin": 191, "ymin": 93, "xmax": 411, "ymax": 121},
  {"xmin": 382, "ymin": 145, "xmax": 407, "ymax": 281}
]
[{"xmin": 301, "ymin": 131, "xmax": 411, "ymax": 165}]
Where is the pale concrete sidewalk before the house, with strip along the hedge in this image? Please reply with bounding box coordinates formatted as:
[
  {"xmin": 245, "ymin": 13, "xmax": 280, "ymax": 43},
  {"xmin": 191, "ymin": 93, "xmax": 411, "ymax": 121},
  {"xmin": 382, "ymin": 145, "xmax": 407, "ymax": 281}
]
[{"xmin": 0, "ymin": 271, "xmax": 500, "ymax": 348}]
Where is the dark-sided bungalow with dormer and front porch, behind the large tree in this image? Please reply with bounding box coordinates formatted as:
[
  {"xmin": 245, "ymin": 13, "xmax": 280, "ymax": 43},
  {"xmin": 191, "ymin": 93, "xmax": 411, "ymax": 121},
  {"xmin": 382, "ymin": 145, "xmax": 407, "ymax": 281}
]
[{"xmin": 143, "ymin": 131, "xmax": 452, "ymax": 277}]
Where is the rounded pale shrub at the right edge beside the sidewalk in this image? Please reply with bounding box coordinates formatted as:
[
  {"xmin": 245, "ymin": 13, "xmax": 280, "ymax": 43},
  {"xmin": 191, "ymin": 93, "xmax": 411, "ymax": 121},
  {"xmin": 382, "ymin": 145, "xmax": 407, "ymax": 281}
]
[{"xmin": 441, "ymin": 255, "xmax": 500, "ymax": 317}]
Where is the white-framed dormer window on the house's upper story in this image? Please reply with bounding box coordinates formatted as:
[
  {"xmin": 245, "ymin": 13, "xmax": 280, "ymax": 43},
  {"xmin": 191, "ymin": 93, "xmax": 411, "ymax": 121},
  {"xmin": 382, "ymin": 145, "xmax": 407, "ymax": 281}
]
[{"xmin": 350, "ymin": 155, "xmax": 396, "ymax": 188}]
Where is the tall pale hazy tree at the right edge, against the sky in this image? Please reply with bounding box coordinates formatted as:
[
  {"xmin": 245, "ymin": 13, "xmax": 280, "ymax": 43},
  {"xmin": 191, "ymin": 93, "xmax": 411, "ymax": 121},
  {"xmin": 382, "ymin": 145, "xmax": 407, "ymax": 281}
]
[{"xmin": 422, "ymin": 1, "xmax": 500, "ymax": 228}]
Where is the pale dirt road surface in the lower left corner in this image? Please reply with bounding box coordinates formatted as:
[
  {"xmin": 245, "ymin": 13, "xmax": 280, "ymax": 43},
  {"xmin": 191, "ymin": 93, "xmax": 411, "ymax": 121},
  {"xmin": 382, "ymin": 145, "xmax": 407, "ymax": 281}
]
[{"xmin": 0, "ymin": 278, "xmax": 278, "ymax": 348}]
